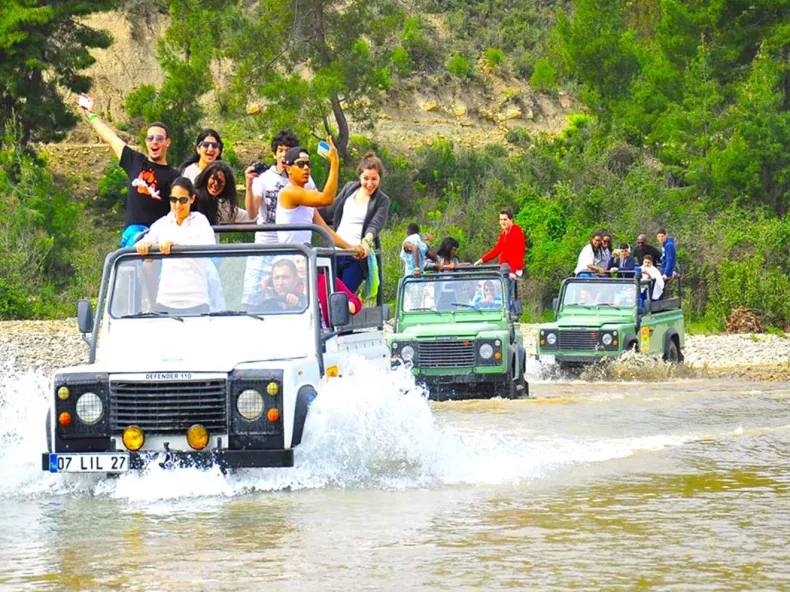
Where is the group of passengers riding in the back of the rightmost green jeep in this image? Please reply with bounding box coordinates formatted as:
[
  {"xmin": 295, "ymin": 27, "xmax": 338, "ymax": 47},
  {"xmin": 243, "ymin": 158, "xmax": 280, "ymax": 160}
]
[{"xmin": 574, "ymin": 228, "xmax": 678, "ymax": 300}]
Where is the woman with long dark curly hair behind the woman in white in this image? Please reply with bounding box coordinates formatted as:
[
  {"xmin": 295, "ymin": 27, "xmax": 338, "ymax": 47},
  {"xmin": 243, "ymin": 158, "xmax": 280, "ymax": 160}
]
[{"xmin": 194, "ymin": 160, "xmax": 250, "ymax": 226}]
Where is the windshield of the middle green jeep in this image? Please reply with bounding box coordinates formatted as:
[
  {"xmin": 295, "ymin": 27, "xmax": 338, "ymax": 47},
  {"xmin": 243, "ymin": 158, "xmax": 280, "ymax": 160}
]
[{"xmin": 403, "ymin": 277, "xmax": 503, "ymax": 312}]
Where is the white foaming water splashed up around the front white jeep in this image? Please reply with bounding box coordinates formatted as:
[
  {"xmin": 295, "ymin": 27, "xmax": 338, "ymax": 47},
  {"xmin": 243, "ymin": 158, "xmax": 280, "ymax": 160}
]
[{"xmin": 0, "ymin": 358, "xmax": 704, "ymax": 503}]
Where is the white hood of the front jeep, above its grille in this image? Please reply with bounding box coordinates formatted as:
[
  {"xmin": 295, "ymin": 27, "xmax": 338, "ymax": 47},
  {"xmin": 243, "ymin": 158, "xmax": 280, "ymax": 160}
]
[{"xmin": 96, "ymin": 317, "xmax": 315, "ymax": 372}]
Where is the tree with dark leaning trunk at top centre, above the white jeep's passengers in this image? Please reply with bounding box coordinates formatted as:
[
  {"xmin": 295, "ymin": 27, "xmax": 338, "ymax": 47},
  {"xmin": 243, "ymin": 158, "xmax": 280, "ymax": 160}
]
[{"xmin": 226, "ymin": 0, "xmax": 405, "ymax": 156}]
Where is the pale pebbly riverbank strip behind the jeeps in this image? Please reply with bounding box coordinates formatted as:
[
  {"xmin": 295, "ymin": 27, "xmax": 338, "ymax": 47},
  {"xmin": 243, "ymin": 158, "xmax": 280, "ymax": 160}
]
[{"xmin": 0, "ymin": 319, "xmax": 790, "ymax": 381}]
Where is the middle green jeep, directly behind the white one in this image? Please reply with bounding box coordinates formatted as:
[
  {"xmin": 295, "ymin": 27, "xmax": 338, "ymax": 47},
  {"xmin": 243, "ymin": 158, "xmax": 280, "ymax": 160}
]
[{"xmin": 387, "ymin": 265, "xmax": 529, "ymax": 400}]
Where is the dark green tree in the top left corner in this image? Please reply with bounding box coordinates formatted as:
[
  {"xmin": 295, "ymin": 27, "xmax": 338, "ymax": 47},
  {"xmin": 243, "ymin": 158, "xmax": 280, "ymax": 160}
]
[{"xmin": 0, "ymin": 0, "xmax": 114, "ymax": 145}]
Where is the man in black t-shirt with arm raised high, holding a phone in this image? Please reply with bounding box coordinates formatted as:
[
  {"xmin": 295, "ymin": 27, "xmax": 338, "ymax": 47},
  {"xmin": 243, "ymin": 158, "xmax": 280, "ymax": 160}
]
[{"xmin": 77, "ymin": 95, "xmax": 180, "ymax": 247}]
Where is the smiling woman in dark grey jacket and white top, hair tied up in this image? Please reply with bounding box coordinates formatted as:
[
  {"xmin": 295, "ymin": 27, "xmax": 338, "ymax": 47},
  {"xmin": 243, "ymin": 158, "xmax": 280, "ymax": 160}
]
[{"xmin": 321, "ymin": 152, "xmax": 390, "ymax": 292}]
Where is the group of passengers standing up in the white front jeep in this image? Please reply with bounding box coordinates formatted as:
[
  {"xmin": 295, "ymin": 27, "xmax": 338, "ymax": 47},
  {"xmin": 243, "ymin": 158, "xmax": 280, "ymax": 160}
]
[{"xmin": 77, "ymin": 95, "xmax": 390, "ymax": 324}]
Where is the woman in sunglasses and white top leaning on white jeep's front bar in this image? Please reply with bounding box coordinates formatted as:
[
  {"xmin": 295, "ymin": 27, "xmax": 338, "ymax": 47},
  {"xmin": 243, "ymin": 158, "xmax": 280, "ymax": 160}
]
[{"xmin": 134, "ymin": 177, "xmax": 214, "ymax": 314}]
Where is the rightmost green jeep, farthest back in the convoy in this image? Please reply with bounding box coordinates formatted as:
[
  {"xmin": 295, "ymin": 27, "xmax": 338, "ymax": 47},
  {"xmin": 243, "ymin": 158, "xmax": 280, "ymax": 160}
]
[{"xmin": 537, "ymin": 277, "xmax": 684, "ymax": 368}]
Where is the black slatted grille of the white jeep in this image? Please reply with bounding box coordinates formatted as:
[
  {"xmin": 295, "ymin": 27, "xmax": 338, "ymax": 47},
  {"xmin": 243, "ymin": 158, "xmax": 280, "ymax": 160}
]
[{"xmin": 110, "ymin": 379, "xmax": 228, "ymax": 434}]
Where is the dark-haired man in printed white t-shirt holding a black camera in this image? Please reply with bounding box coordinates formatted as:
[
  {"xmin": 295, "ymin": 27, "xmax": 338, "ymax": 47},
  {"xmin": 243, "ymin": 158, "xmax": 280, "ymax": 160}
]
[{"xmin": 244, "ymin": 129, "xmax": 316, "ymax": 243}]
